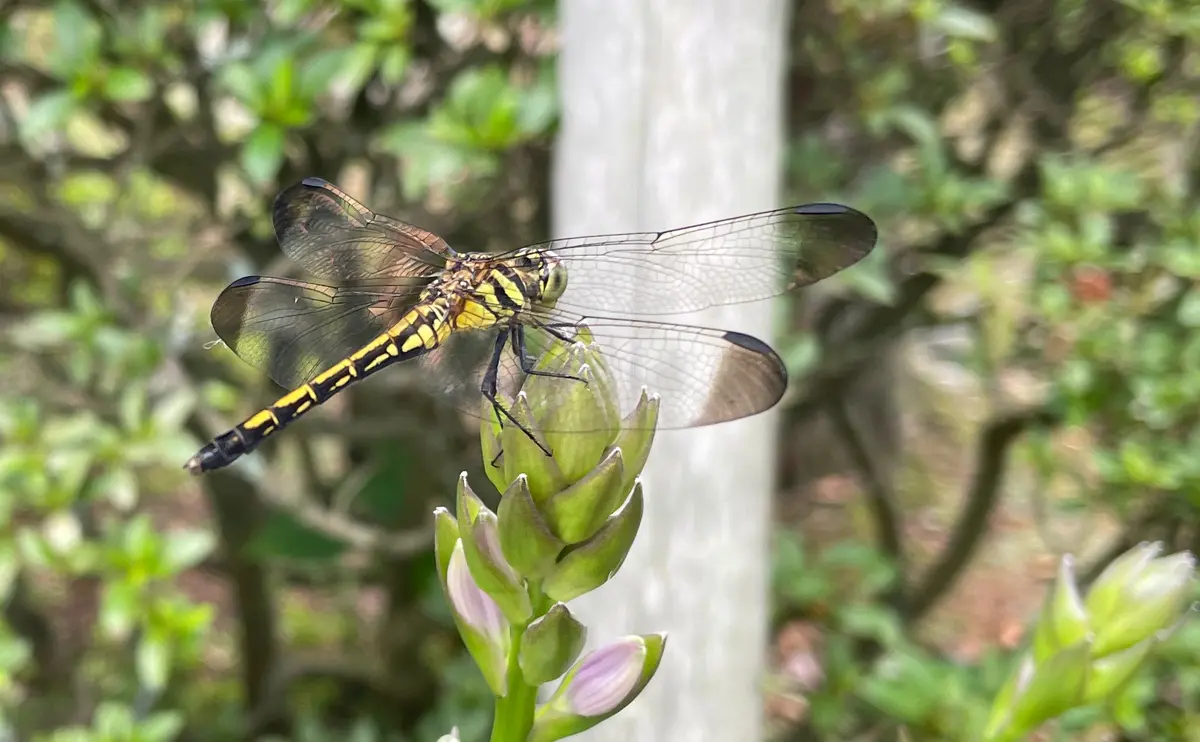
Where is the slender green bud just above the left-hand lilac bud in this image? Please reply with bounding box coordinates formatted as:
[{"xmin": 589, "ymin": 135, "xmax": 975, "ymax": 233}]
[{"xmin": 458, "ymin": 473, "xmax": 533, "ymax": 623}]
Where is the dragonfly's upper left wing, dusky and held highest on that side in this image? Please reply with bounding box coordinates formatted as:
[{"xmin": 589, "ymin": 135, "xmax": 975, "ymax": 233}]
[{"xmin": 272, "ymin": 178, "xmax": 451, "ymax": 285}]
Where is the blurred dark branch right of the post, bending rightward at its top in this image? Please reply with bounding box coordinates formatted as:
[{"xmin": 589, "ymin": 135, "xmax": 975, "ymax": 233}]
[{"xmin": 905, "ymin": 407, "xmax": 1060, "ymax": 624}]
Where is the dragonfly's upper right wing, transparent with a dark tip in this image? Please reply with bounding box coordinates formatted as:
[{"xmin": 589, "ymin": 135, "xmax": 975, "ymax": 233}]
[{"xmin": 501, "ymin": 204, "xmax": 876, "ymax": 315}]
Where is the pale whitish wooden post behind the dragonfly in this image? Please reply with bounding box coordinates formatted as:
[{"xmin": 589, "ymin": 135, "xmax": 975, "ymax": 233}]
[{"xmin": 553, "ymin": 0, "xmax": 787, "ymax": 742}]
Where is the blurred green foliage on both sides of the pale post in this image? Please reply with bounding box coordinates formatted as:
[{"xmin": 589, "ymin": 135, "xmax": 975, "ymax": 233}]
[{"xmin": 0, "ymin": 0, "xmax": 1200, "ymax": 741}]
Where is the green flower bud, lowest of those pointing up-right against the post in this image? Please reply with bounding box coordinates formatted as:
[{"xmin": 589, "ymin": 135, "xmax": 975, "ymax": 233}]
[{"xmin": 542, "ymin": 481, "xmax": 644, "ymax": 603}]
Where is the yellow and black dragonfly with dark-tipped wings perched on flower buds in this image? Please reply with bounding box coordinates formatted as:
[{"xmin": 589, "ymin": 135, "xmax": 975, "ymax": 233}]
[{"xmin": 184, "ymin": 178, "xmax": 877, "ymax": 474}]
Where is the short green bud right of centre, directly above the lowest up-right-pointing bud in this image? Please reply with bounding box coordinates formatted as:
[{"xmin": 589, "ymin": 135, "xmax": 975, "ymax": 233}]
[{"xmin": 542, "ymin": 448, "xmax": 629, "ymax": 544}]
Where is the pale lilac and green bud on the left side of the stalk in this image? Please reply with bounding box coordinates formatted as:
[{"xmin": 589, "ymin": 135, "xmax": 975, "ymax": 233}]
[{"xmin": 442, "ymin": 539, "xmax": 512, "ymax": 696}]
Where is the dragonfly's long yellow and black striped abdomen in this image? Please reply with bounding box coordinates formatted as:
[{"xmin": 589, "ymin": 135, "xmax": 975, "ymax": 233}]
[{"xmin": 184, "ymin": 300, "xmax": 452, "ymax": 474}]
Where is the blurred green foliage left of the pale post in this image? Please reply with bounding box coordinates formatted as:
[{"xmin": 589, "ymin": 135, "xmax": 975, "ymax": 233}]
[{"xmin": 0, "ymin": 0, "xmax": 557, "ymax": 741}]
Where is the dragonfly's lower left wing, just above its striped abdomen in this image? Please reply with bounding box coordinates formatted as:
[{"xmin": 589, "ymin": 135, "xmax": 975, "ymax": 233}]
[{"xmin": 211, "ymin": 271, "xmax": 393, "ymax": 389}]
